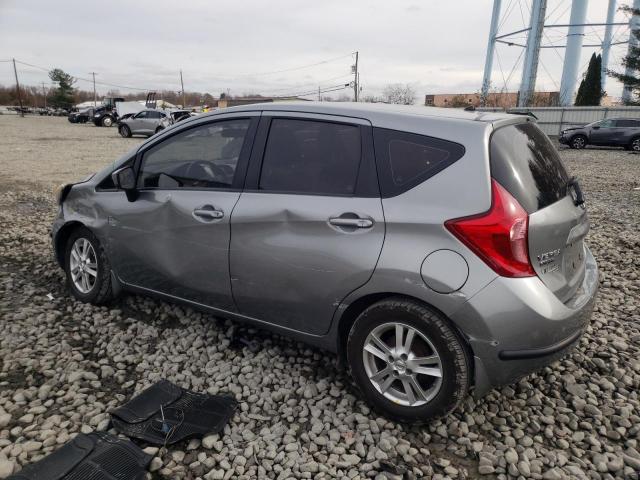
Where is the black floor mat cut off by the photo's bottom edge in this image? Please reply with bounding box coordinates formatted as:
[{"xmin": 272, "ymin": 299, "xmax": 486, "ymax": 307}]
[{"xmin": 7, "ymin": 432, "xmax": 151, "ymax": 480}]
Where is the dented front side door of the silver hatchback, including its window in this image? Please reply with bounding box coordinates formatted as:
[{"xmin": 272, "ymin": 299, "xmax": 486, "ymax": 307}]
[{"xmin": 109, "ymin": 114, "xmax": 257, "ymax": 311}]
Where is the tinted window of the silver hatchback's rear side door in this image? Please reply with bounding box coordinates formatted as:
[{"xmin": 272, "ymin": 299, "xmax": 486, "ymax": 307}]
[{"xmin": 259, "ymin": 119, "xmax": 362, "ymax": 195}]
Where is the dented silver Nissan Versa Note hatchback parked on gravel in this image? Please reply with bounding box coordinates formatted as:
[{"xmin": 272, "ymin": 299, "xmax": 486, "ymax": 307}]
[{"xmin": 52, "ymin": 103, "xmax": 598, "ymax": 423}]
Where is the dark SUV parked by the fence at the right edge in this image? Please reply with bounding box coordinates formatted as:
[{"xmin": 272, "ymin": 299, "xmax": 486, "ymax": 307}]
[{"xmin": 558, "ymin": 118, "xmax": 640, "ymax": 152}]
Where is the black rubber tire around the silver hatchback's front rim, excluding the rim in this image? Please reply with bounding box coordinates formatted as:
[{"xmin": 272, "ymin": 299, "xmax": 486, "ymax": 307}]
[{"xmin": 64, "ymin": 227, "xmax": 113, "ymax": 305}]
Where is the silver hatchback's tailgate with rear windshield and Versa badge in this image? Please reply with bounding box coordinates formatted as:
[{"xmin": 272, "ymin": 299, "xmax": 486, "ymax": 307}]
[{"xmin": 491, "ymin": 122, "xmax": 589, "ymax": 301}]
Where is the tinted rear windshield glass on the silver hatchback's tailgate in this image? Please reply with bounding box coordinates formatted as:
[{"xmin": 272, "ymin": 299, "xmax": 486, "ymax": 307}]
[{"xmin": 491, "ymin": 122, "xmax": 569, "ymax": 213}]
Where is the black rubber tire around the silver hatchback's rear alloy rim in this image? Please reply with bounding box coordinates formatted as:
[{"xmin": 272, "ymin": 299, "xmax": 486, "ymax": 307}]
[{"xmin": 346, "ymin": 298, "xmax": 471, "ymax": 424}]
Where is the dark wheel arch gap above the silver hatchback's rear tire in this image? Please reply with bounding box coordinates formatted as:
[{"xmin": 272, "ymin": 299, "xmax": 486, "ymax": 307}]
[{"xmin": 337, "ymin": 292, "xmax": 475, "ymax": 374}]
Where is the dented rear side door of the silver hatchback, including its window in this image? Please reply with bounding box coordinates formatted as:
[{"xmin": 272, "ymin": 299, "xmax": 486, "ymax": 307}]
[{"xmin": 230, "ymin": 114, "xmax": 385, "ymax": 335}]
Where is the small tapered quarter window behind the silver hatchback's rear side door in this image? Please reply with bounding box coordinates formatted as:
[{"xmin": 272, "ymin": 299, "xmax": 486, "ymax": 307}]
[{"xmin": 373, "ymin": 128, "xmax": 465, "ymax": 197}]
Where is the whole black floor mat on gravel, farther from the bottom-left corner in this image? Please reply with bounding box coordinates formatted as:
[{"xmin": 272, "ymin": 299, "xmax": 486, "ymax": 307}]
[{"xmin": 111, "ymin": 380, "xmax": 237, "ymax": 445}]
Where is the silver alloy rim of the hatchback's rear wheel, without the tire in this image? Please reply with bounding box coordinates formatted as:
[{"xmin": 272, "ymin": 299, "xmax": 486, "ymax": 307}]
[{"xmin": 362, "ymin": 322, "xmax": 443, "ymax": 407}]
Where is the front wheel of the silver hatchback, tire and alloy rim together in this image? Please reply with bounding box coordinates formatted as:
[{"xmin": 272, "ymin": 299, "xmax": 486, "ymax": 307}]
[{"xmin": 64, "ymin": 227, "xmax": 112, "ymax": 305}]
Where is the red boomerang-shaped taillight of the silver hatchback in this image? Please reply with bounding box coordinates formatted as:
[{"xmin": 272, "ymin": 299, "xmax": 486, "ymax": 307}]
[{"xmin": 445, "ymin": 179, "xmax": 536, "ymax": 277}]
